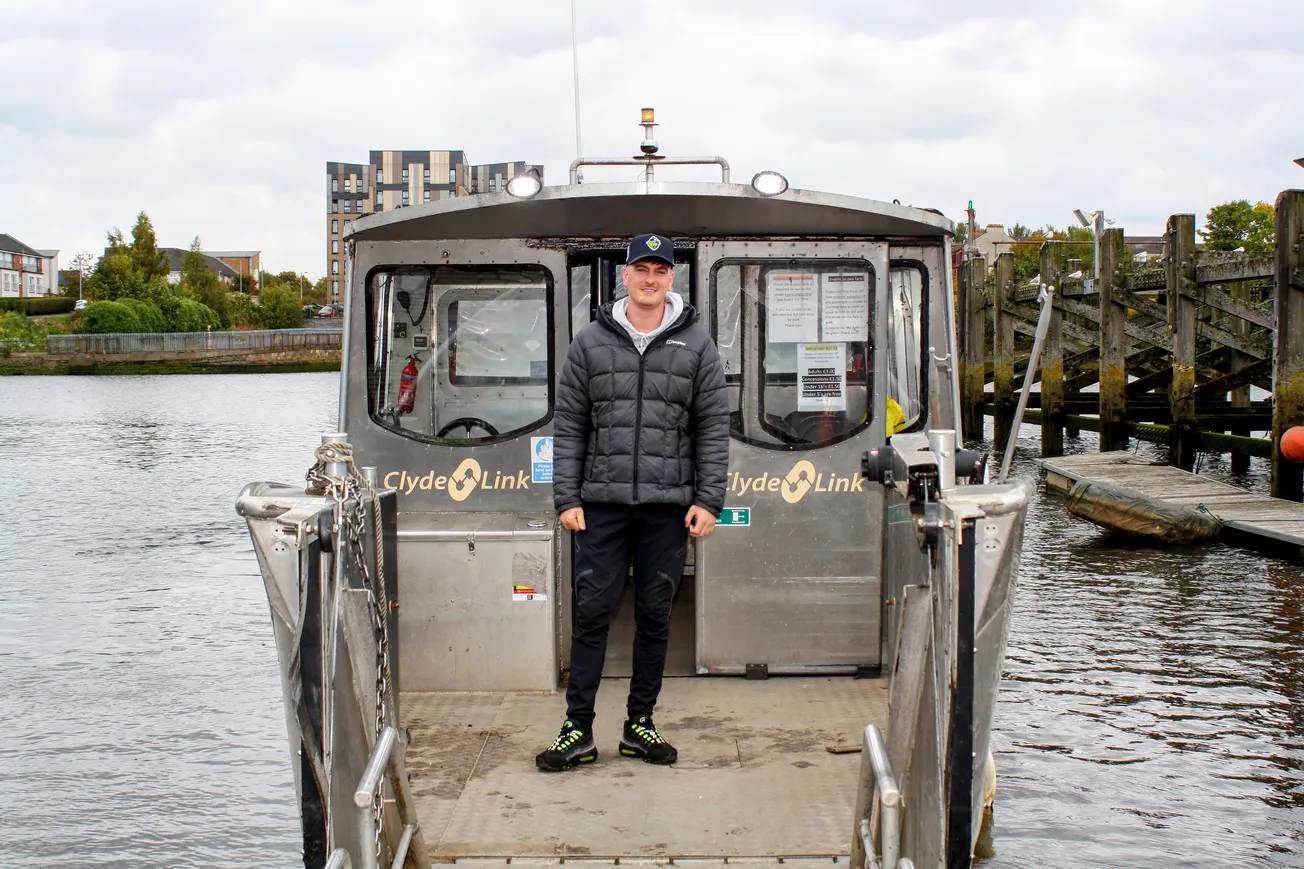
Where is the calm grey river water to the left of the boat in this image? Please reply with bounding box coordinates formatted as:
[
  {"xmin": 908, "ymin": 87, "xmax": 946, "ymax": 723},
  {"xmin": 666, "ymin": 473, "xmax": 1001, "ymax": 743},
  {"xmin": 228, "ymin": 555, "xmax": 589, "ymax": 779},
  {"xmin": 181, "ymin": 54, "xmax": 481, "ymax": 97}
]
[{"xmin": 0, "ymin": 374, "xmax": 336, "ymax": 868}]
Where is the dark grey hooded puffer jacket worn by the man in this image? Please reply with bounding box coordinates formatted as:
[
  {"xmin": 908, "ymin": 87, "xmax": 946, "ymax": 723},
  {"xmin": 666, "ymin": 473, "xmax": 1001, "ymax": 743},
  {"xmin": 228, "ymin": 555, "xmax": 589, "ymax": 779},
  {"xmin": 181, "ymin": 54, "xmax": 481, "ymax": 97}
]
[{"xmin": 553, "ymin": 297, "xmax": 729, "ymax": 515}]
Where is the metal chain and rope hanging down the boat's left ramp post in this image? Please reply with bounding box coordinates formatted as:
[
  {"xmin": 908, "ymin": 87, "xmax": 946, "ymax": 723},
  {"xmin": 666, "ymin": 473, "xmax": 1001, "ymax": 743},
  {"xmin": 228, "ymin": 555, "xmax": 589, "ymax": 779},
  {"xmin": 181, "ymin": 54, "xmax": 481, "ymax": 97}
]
[{"xmin": 305, "ymin": 444, "xmax": 394, "ymax": 861}]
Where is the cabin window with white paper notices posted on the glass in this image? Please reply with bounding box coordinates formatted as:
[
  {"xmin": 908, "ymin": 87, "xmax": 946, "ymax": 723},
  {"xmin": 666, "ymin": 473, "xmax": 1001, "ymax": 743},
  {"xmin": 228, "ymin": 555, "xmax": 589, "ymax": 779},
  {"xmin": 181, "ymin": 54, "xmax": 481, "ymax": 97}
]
[{"xmin": 711, "ymin": 260, "xmax": 874, "ymax": 449}]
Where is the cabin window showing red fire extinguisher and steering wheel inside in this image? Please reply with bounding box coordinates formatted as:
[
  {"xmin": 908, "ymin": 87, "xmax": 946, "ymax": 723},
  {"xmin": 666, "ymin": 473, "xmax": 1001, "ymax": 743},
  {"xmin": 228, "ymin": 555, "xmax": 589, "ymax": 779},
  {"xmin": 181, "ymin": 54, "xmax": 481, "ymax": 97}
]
[{"xmin": 366, "ymin": 265, "xmax": 554, "ymax": 445}]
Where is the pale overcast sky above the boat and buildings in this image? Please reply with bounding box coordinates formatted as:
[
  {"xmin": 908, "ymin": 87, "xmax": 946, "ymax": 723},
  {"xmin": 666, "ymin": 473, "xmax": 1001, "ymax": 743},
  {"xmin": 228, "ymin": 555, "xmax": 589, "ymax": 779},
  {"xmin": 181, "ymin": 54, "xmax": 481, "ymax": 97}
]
[{"xmin": 0, "ymin": 0, "xmax": 1304, "ymax": 279}]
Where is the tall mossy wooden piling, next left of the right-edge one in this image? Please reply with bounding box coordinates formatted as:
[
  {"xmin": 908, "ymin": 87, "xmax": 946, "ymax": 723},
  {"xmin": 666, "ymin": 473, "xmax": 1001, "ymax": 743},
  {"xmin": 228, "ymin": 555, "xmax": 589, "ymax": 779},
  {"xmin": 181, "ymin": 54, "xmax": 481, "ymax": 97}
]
[{"xmin": 1166, "ymin": 214, "xmax": 1198, "ymax": 471}]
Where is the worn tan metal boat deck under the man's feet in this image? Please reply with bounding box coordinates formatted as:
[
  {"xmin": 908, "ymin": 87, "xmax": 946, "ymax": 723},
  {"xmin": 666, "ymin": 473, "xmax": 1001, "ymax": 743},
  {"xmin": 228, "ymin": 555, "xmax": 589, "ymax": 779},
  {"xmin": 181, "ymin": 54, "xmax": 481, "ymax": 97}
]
[{"xmin": 399, "ymin": 676, "xmax": 888, "ymax": 869}]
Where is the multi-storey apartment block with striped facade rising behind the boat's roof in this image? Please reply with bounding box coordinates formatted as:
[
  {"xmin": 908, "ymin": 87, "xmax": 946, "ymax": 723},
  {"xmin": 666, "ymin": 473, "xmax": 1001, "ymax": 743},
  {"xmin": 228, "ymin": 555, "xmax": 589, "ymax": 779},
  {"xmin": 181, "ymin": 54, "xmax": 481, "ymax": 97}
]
[{"xmin": 326, "ymin": 151, "xmax": 544, "ymax": 301}]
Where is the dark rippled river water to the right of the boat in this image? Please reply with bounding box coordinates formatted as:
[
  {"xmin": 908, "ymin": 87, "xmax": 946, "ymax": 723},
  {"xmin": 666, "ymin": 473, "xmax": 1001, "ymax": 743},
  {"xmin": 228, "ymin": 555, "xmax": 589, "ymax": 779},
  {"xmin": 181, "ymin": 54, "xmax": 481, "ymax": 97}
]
[{"xmin": 985, "ymin": 428, "xmax": 1304, "ymax": 869}]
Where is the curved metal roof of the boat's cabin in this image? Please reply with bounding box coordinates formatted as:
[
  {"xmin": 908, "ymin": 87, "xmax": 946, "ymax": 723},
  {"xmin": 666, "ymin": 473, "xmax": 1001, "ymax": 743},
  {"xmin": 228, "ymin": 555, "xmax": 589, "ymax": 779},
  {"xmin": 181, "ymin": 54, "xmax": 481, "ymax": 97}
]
[{"xmin": 347, "ymin": 181, "xmax": 955, "ymax": 241}]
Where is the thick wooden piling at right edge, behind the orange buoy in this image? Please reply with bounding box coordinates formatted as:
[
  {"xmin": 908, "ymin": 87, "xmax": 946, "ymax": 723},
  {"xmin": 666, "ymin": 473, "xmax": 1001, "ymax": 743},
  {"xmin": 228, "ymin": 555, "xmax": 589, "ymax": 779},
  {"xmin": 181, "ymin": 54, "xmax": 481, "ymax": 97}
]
[{"xmin": 1270, "ymin": 191, "xmax": 1304, "ymax": 501}]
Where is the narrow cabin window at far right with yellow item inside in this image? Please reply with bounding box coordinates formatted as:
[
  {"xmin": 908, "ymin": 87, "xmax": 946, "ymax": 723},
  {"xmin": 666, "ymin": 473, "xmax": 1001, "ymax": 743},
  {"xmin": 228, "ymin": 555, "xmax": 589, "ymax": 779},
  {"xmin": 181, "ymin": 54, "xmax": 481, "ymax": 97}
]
[{"xmin": 885, "ymin": 262, "xmax": 927, "ymax": 436}]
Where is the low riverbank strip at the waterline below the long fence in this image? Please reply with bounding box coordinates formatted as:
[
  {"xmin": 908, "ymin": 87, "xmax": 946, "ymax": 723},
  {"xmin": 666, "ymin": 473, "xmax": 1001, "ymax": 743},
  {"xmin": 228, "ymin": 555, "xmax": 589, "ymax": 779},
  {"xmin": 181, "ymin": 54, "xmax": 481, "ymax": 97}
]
[{"xmin": 0, "ymin": 347, "xmax": 340, "ymax": 376}]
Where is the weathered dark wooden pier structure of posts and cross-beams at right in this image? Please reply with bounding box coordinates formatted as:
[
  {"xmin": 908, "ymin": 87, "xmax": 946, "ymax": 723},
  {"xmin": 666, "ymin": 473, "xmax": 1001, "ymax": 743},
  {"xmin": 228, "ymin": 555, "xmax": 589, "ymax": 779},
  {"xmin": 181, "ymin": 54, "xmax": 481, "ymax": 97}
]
[{"xmin": 956, "ymin": 191, "xmax": 1304, "ymax": 501}]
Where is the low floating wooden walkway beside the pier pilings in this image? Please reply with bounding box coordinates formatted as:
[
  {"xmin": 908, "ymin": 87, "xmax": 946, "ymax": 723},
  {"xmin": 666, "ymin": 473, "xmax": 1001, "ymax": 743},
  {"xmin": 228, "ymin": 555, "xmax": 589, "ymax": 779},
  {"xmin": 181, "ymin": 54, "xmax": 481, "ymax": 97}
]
[{"xmin": 1042, "ymin": 451, "xmax": 1304, "ymax": 558}]
